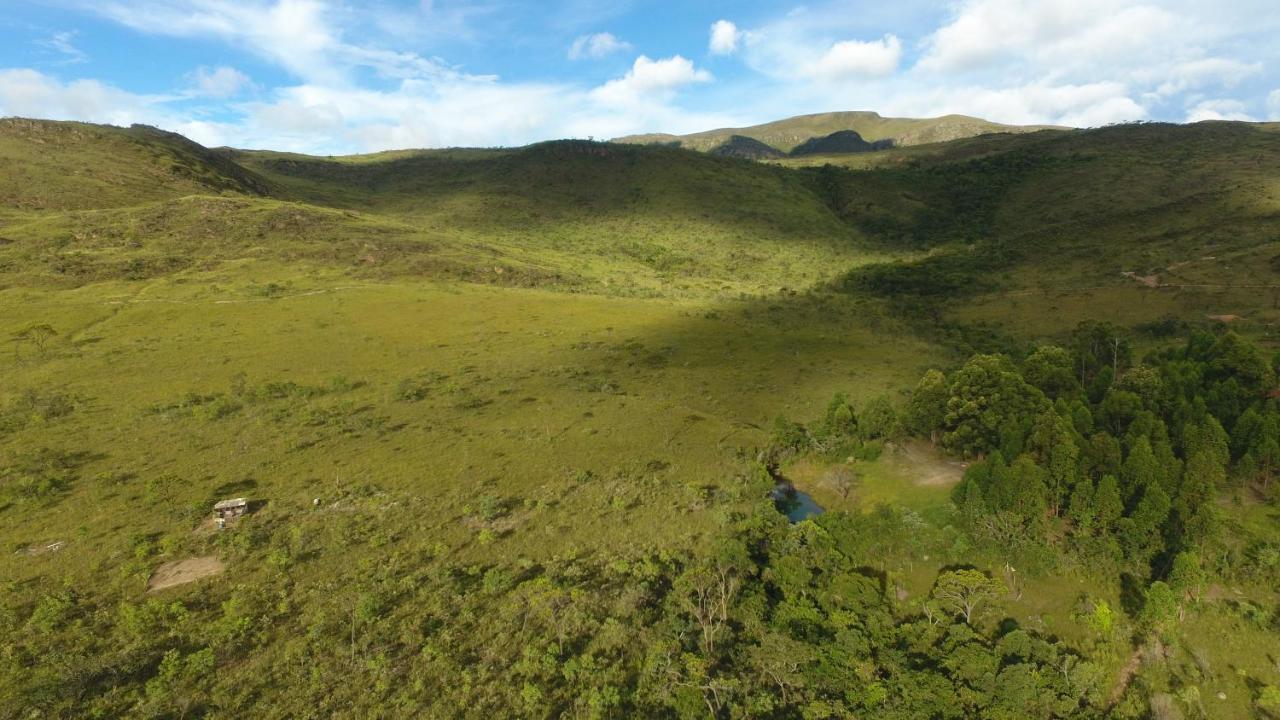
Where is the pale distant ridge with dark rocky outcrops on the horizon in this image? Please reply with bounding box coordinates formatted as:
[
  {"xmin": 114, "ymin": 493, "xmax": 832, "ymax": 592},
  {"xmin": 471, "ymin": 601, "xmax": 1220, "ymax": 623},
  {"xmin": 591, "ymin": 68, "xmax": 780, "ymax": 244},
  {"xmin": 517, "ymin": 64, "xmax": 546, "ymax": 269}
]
[{"xmin": 614, "ymin": 110, "xmax": 1069, "ymax": 152}]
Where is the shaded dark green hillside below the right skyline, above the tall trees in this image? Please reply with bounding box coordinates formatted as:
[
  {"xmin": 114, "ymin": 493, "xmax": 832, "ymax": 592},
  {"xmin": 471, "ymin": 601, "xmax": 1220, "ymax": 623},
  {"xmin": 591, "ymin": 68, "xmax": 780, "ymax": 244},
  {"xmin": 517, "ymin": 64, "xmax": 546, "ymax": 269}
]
[{"xmin": 808, "ymin": 123, "xmax": 1280, "ymax": 337}]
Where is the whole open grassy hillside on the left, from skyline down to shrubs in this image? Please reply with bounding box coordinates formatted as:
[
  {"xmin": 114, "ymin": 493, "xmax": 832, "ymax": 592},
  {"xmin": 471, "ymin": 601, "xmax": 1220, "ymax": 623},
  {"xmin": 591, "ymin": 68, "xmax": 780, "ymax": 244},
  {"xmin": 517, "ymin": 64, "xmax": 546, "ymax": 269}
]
[{"xmin": 0, "ymin": 117, "xmax": 940, "ymax": 617}]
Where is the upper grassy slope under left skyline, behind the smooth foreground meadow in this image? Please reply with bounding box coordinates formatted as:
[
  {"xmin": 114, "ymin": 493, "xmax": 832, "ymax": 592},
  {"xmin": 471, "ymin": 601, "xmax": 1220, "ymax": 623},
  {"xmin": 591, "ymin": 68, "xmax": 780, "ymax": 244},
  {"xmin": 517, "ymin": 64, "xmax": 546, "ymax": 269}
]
[{"xmin": 0, "ymin": 126, "xmax": 906, "ymax": 296}]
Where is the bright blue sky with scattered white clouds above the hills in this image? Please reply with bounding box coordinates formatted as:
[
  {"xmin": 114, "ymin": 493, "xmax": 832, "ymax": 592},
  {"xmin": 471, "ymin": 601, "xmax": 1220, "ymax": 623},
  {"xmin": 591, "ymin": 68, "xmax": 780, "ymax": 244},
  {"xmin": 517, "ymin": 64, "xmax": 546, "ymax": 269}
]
[{"xmin": 0, "ymin": 0, "xmax": 1280, "ymax": 154}]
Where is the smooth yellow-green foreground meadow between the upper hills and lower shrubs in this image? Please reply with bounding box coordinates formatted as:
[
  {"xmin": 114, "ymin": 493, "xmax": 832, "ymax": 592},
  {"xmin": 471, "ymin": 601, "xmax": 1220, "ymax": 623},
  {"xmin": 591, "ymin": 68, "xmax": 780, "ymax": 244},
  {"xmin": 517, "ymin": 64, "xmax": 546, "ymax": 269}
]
[{"xmin": 0, "ymin": 264, "xmax": 929, "ymax": 578}]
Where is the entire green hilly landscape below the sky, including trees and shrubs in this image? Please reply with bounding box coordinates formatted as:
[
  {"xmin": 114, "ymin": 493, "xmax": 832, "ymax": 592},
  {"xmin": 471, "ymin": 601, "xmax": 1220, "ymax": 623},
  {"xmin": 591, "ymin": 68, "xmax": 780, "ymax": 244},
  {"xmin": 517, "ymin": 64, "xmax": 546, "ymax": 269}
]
[{"xmin": 0, "ymin": 114, "xmax": 1280, "ymax": 720}]
